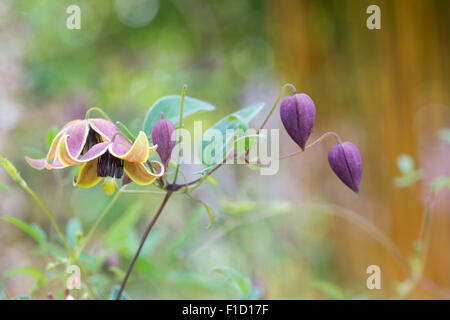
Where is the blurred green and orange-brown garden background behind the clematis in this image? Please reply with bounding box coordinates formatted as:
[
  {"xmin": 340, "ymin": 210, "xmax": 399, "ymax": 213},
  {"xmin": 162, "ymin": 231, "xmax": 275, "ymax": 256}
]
[{"xmin": 0, "ymin": 0, "xmax": 450, "ymax": 299}]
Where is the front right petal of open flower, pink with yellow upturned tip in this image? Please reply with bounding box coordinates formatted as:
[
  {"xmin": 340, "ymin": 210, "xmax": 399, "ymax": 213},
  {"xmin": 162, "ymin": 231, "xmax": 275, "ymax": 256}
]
[{"xmin": 109, "ymin": 131, "xmax": 151, "ymax": 163}]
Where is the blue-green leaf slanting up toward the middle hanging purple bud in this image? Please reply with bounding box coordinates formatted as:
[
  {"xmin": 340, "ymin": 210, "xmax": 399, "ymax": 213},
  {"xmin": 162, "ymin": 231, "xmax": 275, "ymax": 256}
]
[{"xmin": 199, "ymin": 103, "xmax": 264, "ymax": 169}]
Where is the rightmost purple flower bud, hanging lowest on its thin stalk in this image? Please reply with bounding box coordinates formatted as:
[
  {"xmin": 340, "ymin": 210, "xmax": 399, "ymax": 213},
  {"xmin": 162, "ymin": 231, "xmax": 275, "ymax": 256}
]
[{"xmin": 328, "ymin": 142, "xmax": 362, "ymax": 193}]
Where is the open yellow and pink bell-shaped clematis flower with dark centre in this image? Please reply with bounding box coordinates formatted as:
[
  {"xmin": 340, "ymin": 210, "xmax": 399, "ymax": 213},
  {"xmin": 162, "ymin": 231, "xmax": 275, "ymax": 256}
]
[{"xmin": 26, "ymin": 119, "xmax": 164, "ymax": 195}]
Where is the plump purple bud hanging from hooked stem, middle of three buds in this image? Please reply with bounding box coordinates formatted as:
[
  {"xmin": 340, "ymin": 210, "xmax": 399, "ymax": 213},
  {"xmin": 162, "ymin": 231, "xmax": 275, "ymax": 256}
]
[{"xmin": 280, "ymin": 93, "xmax": 316, "ymax": 150}]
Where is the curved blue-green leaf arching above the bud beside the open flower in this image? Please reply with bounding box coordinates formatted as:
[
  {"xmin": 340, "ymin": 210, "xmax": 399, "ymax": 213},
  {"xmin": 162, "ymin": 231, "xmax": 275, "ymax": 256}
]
[{"xmin": 143, "ymin": 95, "xmax": 216, "ymax": 139}]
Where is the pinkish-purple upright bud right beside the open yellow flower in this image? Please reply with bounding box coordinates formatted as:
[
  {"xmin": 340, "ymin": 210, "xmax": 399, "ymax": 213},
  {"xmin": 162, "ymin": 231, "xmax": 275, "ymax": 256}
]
[{"xmin": 152, "ymin": 112, "xmax": 176, "ymax": 170}]
